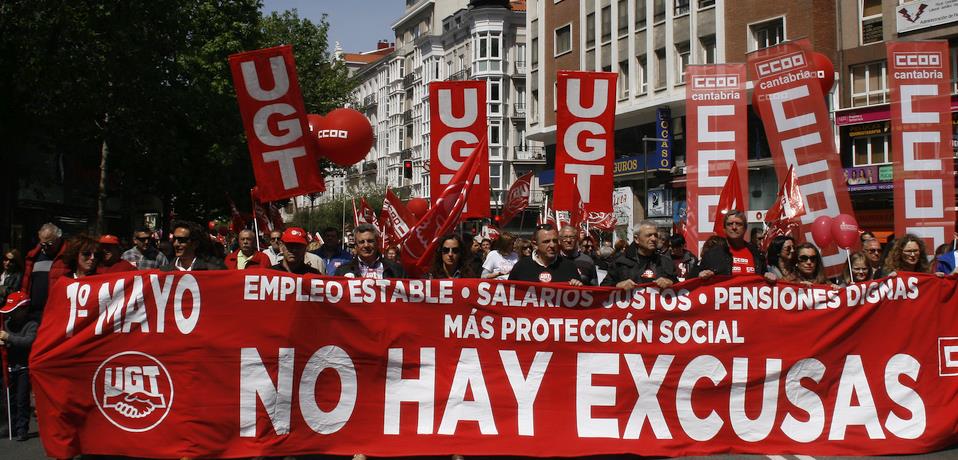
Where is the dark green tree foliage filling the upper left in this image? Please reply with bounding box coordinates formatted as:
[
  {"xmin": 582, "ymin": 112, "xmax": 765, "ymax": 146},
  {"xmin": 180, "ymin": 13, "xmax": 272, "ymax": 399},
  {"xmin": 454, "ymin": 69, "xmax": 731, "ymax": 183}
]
[{"xmin": 0, "ymin": 0, "xmax": 352, "ymax": 230}]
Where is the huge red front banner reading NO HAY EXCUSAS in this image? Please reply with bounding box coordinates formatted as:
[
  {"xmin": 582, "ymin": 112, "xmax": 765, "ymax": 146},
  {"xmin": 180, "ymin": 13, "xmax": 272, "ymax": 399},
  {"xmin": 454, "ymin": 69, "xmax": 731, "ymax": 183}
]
[{"xmin": 30, "ymin": 270, "xmax": 958, "ymax": 458}]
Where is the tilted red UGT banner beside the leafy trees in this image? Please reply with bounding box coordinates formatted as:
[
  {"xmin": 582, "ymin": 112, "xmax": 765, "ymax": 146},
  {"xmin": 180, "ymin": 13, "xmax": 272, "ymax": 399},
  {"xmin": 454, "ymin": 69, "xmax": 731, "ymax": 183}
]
[{"xmin": 229, "ymin": 45, "xmax": 326, "ymax": 201}]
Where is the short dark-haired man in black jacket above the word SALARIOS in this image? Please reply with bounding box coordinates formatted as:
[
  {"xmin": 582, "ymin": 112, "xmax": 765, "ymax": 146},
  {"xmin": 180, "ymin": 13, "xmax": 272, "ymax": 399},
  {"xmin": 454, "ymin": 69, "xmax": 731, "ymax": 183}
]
[{"xmin": 509, "ymin": 224, "xmax": 582, "ymax": 286}]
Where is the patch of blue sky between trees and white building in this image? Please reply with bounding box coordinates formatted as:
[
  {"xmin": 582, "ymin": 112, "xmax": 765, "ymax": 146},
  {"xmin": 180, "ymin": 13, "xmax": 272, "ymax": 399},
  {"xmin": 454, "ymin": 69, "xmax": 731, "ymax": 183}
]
[{"xmin": 263, "ymin": 0, "xmax": 405, "ymax": 52}]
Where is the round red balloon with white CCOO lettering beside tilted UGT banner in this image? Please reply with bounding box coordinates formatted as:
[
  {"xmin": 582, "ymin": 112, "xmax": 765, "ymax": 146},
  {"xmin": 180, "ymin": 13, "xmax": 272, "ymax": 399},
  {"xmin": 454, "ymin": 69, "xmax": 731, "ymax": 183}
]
[{"xmin": 316, "ymin": 109, "xmax": 373, "ymax": 166}]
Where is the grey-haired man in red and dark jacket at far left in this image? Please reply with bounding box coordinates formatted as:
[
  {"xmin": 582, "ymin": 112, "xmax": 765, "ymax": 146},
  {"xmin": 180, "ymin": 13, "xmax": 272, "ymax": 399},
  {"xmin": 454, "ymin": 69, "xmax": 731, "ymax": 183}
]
[{"xmin": 20, "ymin": 222, "xmax": 70, "ymax": 312}]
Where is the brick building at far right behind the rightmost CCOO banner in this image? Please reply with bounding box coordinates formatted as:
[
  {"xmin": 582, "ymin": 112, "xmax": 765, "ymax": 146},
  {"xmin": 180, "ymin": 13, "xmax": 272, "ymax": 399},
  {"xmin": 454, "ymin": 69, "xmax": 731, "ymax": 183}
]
[{"xmin": 835, "ymin": 0, "xmax": 958, "ymax": 236}]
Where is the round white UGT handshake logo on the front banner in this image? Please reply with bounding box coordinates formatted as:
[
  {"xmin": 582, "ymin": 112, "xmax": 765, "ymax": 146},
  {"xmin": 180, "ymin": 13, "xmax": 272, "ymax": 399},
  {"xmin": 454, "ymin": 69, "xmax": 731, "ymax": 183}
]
[{"xmin": 93, "ymin": 351, "xmax": 173, "ymax": 432}]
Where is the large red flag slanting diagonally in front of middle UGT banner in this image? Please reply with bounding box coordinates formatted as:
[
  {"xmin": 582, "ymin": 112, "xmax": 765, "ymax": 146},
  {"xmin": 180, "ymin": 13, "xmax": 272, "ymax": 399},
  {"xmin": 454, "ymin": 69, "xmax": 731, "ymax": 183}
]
[{"xmin": 402, "ymin": 136, "xmax": 489, "ymax": 276}]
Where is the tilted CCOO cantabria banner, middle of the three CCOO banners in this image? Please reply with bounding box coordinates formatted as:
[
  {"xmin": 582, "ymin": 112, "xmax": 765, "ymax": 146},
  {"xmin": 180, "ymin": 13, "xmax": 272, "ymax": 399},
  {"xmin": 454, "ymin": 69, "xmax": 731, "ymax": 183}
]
[{"xmin": 748, "ymin": 42, "xmax": 855, "ymax": 276}]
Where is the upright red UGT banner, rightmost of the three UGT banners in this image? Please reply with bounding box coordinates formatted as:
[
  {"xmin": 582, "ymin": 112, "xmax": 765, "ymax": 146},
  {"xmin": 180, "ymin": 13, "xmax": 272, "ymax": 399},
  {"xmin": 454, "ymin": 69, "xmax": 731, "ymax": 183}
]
[{"xmin": 552, "ymin": 70, "xmax": 617, "ymax": 212}]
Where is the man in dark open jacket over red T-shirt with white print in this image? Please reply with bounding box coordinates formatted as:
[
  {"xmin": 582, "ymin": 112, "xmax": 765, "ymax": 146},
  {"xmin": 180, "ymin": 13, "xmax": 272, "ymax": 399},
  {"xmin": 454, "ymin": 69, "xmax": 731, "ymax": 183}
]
[{"xmin": 689, "ymin": 209, "xmax": 777, "ymax": 281}]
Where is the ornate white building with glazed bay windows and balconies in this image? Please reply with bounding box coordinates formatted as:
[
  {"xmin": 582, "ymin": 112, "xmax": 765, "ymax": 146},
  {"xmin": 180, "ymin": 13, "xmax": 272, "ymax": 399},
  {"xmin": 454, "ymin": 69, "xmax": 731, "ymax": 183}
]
[{"xmin": 303, "ymin": 0, "xmax": 545, "ymax": 227}]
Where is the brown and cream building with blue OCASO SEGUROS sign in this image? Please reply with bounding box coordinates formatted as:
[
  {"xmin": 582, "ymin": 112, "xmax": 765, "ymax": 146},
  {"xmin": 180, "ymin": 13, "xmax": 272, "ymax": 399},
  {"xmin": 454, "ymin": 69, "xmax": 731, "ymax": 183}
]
[{"xmin": 526, "ymin": 0, "xmax": 836, "ymax": 227}]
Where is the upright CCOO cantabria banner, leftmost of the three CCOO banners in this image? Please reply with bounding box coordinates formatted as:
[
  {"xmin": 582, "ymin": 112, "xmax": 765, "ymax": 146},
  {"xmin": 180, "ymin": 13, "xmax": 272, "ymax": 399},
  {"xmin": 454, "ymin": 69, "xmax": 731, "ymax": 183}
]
[{"xmin": 685, "ymin": 64, "xmax": 748, "ymax": 256}]
